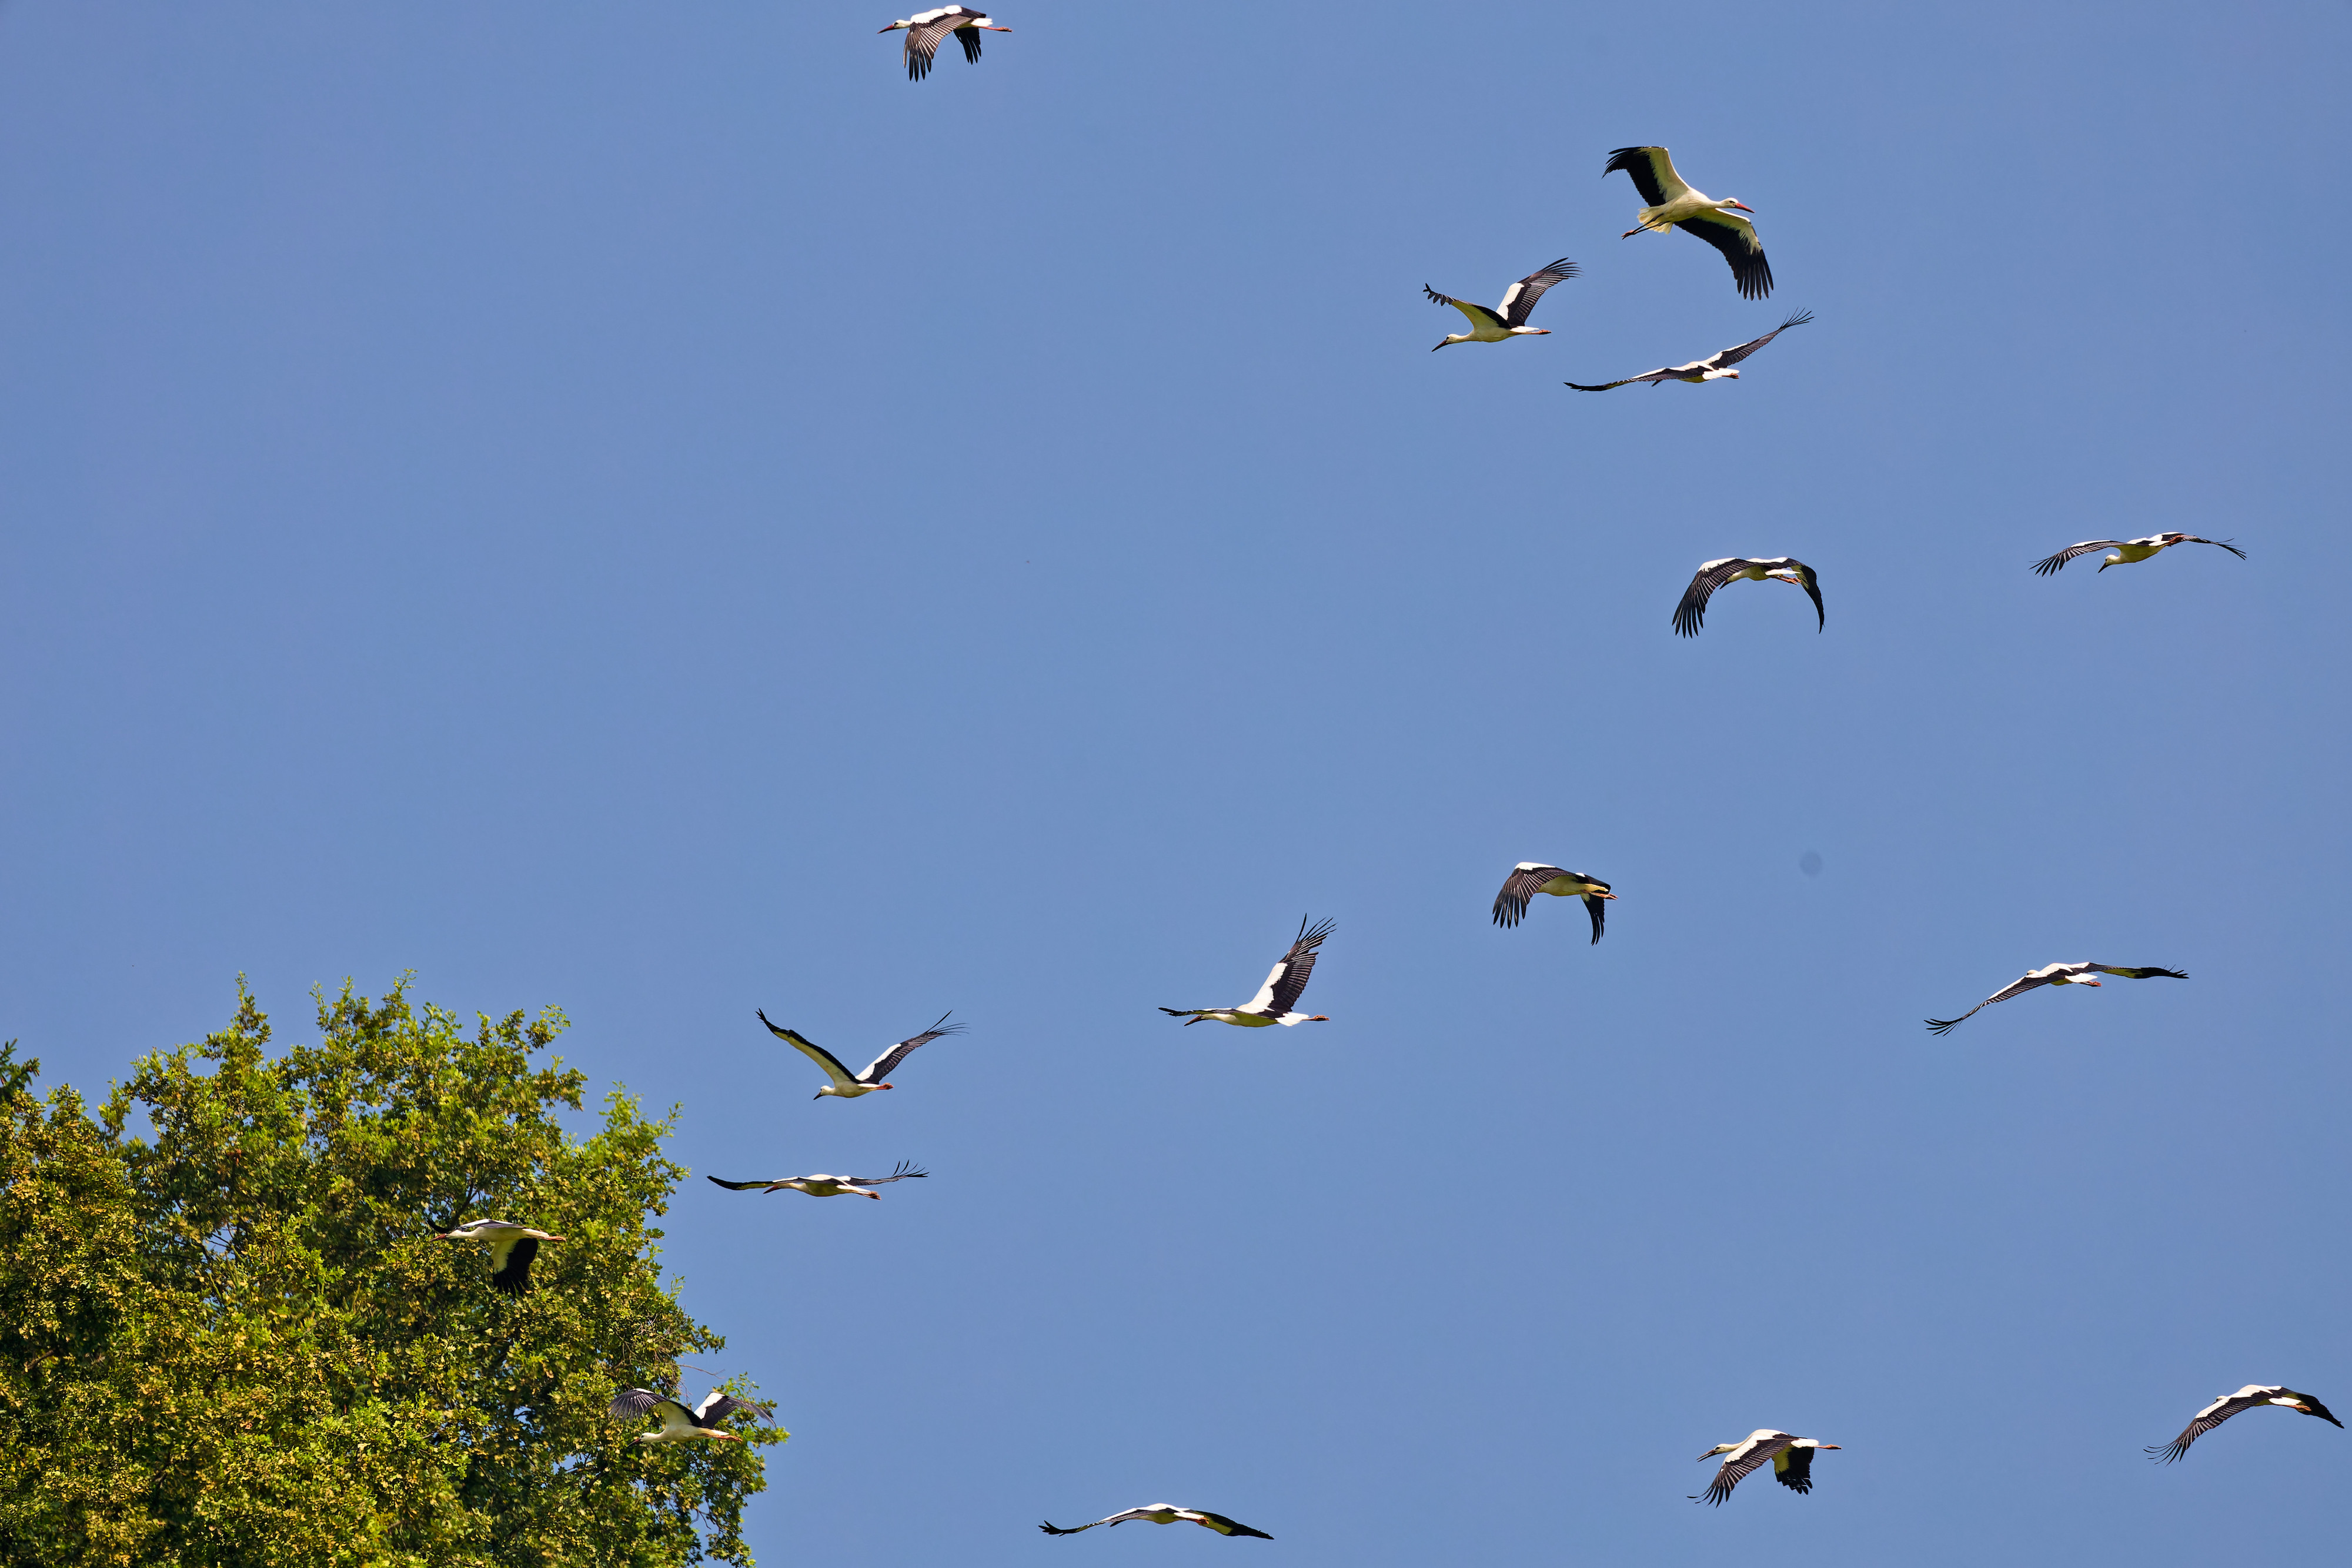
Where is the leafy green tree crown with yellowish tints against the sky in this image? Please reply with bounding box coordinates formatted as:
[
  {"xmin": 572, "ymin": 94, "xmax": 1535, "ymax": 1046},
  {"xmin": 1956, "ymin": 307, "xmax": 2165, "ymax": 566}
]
[{"xmin": 0, "ymin": 985, "xmax": 786, "ymax": 1568}]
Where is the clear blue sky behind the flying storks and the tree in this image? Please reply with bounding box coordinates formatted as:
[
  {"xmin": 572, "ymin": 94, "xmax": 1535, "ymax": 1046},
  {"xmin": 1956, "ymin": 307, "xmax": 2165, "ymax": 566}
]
[{"xmin": 0, "ymin": 0, "xmax": 2352, "ymax": 1568}]
